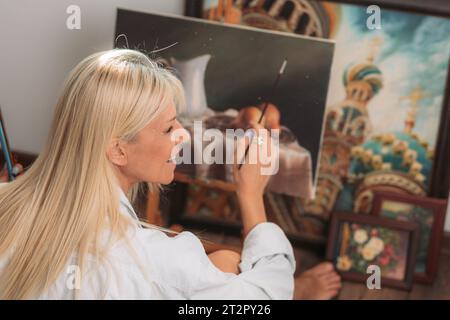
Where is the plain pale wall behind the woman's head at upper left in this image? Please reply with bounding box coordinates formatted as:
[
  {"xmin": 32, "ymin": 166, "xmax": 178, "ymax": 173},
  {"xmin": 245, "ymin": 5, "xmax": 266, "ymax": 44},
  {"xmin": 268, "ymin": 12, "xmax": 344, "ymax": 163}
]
[{"xmin": 0, "ymin": 0, "xmax": 184, "ymax": 154}]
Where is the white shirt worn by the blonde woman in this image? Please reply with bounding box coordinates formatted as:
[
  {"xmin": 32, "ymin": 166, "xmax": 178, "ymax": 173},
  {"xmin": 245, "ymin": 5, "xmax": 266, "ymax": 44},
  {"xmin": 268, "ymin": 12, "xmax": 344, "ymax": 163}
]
[{"xmin": 0, "ymin": 185, "xmax": 296, "ymax": 299}]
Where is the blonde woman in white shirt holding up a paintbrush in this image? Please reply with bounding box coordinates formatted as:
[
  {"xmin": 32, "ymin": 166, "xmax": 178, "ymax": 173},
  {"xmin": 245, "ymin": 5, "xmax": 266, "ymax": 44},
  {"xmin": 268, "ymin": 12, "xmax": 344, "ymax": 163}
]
[{"xmin": 0, "ymin": 49, "xmax": 342, "ymax": 299}]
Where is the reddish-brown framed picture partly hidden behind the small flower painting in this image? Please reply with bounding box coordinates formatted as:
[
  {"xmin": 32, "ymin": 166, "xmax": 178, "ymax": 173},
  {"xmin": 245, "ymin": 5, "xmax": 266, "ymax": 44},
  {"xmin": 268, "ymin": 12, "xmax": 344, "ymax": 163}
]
[{"xmin": 371, "ymin": 191, "xmax": 447, "ymax": 284}]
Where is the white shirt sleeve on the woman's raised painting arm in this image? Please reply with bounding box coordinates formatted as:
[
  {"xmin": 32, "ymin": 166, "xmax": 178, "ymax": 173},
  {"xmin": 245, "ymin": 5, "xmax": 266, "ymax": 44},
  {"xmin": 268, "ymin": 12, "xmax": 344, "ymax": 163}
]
[{"xmin": 188, "ymin": 222, "xmax": 296, "ymax": 300}]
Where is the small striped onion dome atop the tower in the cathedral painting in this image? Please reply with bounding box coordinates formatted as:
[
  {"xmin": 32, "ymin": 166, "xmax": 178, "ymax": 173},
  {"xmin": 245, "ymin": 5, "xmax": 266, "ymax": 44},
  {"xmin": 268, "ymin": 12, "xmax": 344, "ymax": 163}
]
[{"xmin": 343, "ymin": 62, "xmax": 383, "ymax": 94}]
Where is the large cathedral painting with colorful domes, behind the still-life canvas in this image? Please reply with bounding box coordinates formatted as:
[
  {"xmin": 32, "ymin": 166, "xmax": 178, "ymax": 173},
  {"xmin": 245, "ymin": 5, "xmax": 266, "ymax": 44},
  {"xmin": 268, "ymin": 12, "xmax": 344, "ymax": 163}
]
[{"xmin": 190, "ymin": 0, "xmax": 450, "ymax": 240}]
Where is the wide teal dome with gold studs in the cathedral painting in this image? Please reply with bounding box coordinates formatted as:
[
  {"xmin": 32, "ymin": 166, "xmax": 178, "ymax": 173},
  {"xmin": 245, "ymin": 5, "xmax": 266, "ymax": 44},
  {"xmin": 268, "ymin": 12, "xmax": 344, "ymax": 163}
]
[{"xmin": 349, "ymin": 132, "xmax": 433, "ymax": 189}]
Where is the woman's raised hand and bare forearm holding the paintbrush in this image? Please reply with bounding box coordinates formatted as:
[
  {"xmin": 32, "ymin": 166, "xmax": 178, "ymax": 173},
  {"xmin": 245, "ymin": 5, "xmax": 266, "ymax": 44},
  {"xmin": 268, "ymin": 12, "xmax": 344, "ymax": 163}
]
[{"xmin": 233, "ymin": 123, "xmax": 272, "ymax": 237}]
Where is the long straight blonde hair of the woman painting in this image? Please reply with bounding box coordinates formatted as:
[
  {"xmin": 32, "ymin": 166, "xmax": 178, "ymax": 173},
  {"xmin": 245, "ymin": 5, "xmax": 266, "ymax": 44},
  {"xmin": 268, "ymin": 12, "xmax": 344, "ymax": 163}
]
[{"xmin": 0, "ymin": 49, "xmax": 183, "ymax": 299}]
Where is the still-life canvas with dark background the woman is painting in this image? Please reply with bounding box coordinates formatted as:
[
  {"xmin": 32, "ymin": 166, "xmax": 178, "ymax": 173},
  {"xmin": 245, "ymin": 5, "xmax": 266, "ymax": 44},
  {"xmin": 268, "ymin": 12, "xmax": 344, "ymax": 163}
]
[{"xmin": 116, "ymin": 10, "xmax": 334, "ymax": 197}]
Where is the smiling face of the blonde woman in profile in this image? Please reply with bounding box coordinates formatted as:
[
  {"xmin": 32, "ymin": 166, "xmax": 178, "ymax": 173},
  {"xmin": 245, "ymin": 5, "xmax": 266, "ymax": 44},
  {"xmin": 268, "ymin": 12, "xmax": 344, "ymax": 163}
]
[{"xmin": 119, "ymin": 106, "xmax": 188, "ymax": 186}]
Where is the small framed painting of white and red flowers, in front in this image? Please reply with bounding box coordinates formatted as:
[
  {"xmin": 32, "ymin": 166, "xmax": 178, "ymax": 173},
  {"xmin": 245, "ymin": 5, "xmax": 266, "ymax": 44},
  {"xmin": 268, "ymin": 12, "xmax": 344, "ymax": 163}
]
[{"xmin": 326, "ymin": 212, "xmax": 419, "ymax": 290}]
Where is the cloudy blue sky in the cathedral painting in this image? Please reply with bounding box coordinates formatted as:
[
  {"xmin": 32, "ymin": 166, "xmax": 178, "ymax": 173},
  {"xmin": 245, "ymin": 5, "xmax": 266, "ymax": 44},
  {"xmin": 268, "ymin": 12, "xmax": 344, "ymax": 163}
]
[{"xmin": 328, "ymin": 5, "xmax": 450, "ymax": 146}]
